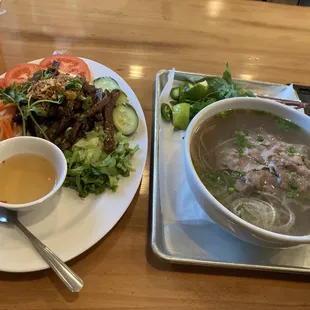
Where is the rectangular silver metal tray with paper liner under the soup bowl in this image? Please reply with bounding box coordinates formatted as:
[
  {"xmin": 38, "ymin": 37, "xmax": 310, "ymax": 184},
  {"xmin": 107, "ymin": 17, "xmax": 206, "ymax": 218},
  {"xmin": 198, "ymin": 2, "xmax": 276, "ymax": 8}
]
[{"xmin": 152, "ymin": 70, "xmax": 310, "ymax": 274}]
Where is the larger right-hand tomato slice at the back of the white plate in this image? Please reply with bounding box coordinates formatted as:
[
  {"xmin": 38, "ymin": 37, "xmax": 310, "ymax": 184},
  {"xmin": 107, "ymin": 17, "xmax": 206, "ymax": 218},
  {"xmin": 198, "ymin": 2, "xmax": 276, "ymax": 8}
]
[{"xmin": 40, "ymin": 55, "xmax": 91, "ymax": 81}]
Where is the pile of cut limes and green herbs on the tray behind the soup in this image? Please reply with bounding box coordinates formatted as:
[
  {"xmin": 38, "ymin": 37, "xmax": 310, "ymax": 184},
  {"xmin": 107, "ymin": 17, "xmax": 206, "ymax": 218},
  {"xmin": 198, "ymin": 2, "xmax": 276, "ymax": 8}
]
[{"xmin": 161, "ymin": 63, "xmax": 255, "ymax": 130}]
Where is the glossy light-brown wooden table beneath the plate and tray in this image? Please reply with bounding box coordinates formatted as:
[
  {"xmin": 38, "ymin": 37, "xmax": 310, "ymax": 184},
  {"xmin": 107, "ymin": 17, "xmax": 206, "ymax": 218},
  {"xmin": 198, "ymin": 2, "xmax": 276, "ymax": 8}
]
[{"xmin": 0, "ymin": 0, "xmax": 310, "ymax": 310}]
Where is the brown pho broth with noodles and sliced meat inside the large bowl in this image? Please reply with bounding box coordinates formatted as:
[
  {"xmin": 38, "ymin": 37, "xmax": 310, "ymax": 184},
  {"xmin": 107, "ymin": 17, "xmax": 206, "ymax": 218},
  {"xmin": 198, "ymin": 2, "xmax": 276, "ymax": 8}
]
[{"xmin": 190, "ymin": 109, "xmax": 310, "ymax": 235}]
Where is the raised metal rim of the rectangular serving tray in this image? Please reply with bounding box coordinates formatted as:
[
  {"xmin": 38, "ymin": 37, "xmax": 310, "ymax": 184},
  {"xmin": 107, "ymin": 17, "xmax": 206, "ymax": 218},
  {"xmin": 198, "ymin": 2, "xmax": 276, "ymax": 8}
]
[{"xmin": 151, "ymin": 69, "xmax": 310, "ymax": 274}]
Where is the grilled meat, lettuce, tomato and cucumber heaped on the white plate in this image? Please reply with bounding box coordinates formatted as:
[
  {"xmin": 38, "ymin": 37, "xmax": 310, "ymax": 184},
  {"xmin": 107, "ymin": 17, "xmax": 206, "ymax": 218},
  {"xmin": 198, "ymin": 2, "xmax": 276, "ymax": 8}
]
[{"xmin": 0, "ymin": 55, "xmax": 139, "ymax": 197}]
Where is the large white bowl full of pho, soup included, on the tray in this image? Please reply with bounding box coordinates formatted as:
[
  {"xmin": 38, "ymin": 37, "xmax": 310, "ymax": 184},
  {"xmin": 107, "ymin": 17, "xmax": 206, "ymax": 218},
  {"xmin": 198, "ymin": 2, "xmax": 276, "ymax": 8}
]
[{"xmin": 184, "ymin": 98, "xmax": 310, "ymax": 247}]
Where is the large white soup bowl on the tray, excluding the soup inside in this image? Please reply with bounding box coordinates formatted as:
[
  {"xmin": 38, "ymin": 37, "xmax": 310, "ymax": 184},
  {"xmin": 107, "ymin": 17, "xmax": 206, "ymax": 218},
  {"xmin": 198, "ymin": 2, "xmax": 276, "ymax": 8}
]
[{"xmin": 184, "ymin": 98, "xmax": 310, "ymax": 247}]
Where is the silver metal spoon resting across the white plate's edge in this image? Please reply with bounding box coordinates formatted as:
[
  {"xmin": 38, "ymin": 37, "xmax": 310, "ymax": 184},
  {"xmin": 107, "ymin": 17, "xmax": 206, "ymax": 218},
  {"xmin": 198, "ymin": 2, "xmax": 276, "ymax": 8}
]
[{"xmin": 0, "ymin": 207, "xmax": 83, "ymax": 292}]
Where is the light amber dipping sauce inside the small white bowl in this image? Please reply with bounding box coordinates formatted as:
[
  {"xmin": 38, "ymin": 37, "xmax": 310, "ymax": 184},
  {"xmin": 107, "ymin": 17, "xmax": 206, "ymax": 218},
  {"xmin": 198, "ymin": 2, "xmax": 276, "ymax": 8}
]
[{"xmin": 0, "ymin": 154, "xmax": 57, "ymax": 204}]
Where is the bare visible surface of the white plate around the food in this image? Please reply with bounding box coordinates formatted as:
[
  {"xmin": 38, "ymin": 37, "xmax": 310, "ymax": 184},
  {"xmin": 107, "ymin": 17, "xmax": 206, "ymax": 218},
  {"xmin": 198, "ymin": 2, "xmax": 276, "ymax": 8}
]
[{"xmin": 0, "ymin": 58, "xmax": 148, "ymax": 272}]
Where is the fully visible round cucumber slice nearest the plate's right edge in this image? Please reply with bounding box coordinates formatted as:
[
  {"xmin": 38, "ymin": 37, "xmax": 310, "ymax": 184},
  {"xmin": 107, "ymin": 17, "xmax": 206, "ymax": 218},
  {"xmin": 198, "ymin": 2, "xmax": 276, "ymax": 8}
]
[{"xmin": 113, "ymin": 104, "xmax": 139, "ymax": 136}]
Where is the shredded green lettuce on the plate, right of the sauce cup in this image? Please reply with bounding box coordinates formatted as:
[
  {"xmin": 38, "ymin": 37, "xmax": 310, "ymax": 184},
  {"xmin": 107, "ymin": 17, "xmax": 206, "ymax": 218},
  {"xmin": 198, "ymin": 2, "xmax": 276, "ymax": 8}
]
[{"xmin": 64, "ymin": 127, "xmax": 139, "ymax": 197}]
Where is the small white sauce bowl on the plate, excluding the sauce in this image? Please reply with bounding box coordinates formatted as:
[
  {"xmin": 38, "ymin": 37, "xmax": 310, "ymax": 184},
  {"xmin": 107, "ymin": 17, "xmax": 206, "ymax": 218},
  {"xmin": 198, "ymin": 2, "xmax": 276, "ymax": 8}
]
[{"xmin": 0, "ymin": 136, "xmax": 67, "ymax": 211}]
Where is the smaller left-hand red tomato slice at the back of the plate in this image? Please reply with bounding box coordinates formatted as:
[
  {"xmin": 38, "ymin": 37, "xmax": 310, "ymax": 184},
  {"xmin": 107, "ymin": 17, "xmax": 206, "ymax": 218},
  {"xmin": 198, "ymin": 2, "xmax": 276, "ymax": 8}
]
[{"xmin": 4, "ymin": 64, "xmax": 40, "ymax": 86}]
